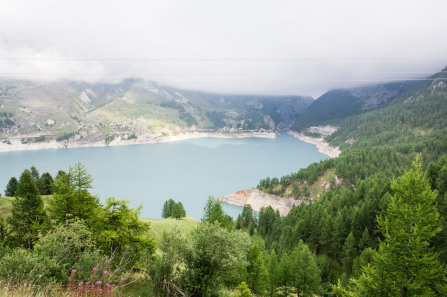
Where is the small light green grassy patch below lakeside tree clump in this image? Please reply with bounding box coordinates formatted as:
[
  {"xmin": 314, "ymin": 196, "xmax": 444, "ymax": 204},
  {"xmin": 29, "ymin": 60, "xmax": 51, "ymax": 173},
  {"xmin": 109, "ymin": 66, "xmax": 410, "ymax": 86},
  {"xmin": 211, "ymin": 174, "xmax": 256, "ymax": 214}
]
[{"xmin": 140, "ymin": 217, "xmax": 199, "ymax": 242}]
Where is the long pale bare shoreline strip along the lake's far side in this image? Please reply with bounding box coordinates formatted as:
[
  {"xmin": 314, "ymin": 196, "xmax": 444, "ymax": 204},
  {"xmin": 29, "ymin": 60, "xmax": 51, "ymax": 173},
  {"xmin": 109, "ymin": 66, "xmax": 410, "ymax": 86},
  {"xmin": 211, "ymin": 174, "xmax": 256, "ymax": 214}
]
[{"xmin": 0, "ymin": 131, "xmax": 278, "ymax": 153}]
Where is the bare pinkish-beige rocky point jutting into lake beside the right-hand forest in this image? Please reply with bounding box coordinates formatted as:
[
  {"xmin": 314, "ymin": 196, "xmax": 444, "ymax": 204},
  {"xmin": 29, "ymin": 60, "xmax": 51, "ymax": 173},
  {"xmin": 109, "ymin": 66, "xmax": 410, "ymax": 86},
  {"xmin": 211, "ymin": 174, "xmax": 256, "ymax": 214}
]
[{"xmin": 219, "ymin": 189, "xmax": 303, "ymax": 216}]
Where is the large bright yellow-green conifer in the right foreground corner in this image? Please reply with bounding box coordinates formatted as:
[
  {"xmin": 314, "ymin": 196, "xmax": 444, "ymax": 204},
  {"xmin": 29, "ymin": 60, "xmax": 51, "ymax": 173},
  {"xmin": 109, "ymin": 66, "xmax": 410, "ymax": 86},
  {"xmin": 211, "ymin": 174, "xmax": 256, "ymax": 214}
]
[{"xmin": 334, "ymin": 156, "xmax": 443, "ymax": 297}]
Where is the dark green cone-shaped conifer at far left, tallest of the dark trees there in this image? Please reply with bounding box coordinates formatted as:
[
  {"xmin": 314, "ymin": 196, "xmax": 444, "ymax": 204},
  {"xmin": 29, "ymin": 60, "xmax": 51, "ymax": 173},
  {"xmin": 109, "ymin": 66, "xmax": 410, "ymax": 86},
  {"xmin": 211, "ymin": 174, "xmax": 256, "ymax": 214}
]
[{"xmin": 8, "ymin": 170, "xmax": 47, "ymax": 250}]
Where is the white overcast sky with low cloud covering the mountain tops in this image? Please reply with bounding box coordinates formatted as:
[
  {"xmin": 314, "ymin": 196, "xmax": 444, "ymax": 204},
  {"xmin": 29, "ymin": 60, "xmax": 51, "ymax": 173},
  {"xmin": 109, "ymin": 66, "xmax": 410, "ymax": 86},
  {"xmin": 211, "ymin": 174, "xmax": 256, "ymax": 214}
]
[{"xmin": 0, "ymin": 0, "xmax": 447, "ymax": 96}]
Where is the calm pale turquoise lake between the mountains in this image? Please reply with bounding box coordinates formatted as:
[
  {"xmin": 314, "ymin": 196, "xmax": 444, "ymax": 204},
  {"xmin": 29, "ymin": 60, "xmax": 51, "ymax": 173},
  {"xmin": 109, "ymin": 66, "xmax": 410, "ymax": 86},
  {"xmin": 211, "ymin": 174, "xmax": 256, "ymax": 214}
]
[{"xmin": 0, "ymin": 134, "xmax": 328, "ymax": 219}]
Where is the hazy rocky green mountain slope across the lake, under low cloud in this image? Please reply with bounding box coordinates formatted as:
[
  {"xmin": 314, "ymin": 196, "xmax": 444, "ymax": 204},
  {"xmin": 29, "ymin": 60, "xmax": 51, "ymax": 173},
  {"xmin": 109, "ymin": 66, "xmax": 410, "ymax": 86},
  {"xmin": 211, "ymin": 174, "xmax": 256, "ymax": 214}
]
[{"xmin": 0, "ymin": 79, "xmax": 312, "ymax": 143}]
